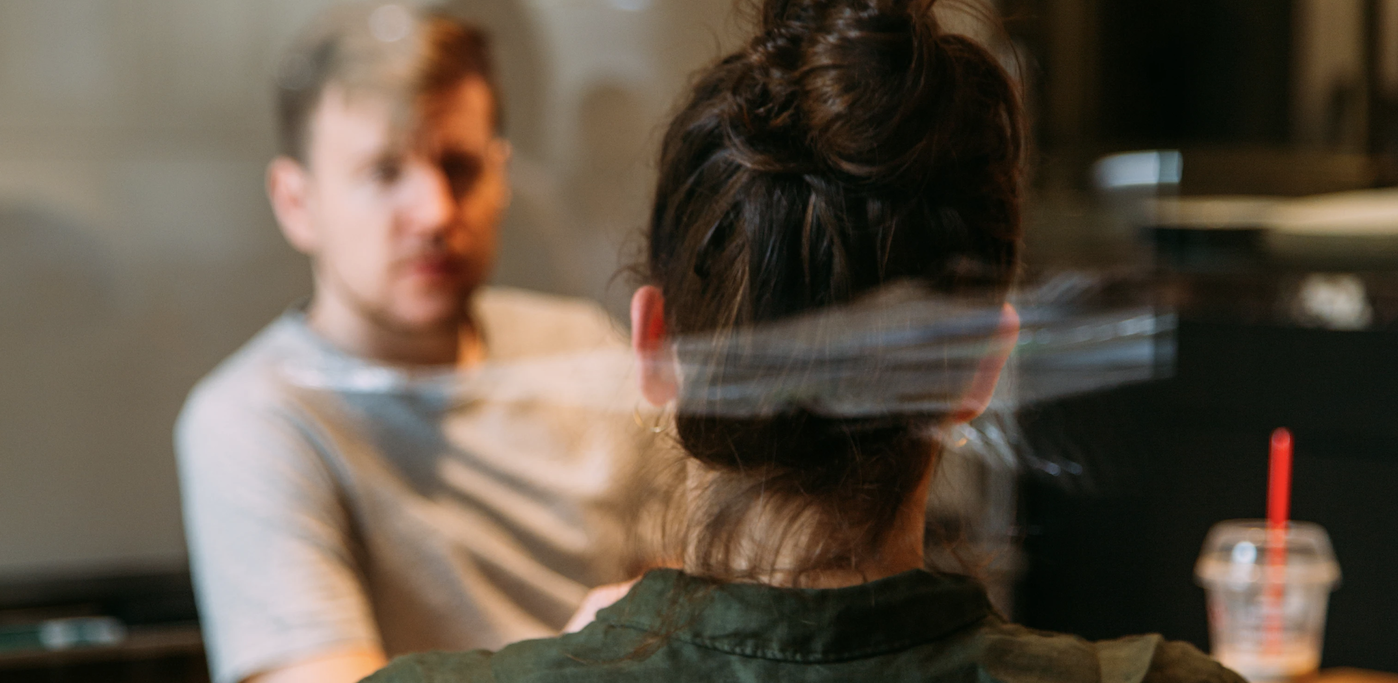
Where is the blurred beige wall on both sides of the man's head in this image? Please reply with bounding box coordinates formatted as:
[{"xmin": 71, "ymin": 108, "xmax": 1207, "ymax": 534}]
[{"xmin": 0, "ymin": 0, "xmax": 734, "ymax": 577}]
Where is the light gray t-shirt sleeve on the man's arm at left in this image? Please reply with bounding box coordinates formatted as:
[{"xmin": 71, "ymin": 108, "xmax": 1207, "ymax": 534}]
[{"xmin": 175, "ymin": 387, "xmax": 382, "ymax": 683}]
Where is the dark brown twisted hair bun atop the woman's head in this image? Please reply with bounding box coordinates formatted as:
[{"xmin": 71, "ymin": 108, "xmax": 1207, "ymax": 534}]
[{"xmin": 730, "ymin": 0, "xmax": 1019, "ymax": 193}]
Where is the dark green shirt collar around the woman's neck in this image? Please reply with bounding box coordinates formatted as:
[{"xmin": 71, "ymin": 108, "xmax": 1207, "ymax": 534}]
[{"xmin": 598, "ymin": 570, "xmax": 994, "ymax": 662}]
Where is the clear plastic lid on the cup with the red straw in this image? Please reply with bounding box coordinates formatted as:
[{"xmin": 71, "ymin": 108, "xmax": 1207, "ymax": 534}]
[{"xmin": 1194, "ymin": 520, "xmax": 1339, "ymax": 587}]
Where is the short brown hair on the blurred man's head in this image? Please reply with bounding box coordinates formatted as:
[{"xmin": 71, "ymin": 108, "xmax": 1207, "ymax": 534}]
[{"xmin": 277, "ymin": 3, "xmax": 502, "ymax": 163}]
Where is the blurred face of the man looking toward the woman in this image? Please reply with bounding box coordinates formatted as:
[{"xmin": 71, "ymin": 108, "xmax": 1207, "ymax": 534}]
[{"xmin": 282, "ymin": 78, "xmax": 509, "ymax": 334}]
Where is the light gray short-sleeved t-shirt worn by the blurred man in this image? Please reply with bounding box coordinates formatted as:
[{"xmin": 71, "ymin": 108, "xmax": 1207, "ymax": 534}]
[{"xmin": 176, "ymin": 289, "xmax": 651, "ymax": 683}]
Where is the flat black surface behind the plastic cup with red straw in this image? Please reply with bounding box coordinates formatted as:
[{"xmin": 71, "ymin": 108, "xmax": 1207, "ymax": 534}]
[{"xmin": 1016, "ymin": 320, "xmax": 1398, "ymax": 670}]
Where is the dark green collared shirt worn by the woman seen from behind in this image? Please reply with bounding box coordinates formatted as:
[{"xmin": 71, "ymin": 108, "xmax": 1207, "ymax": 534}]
[{"xmin": 366, "ymin": 570, "xmax": 1243, "ymax": 683}]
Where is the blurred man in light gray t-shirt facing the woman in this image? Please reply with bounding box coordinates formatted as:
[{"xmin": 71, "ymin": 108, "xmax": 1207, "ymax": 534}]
[{"xmin": 176, "ymin": 4, "xmax": 646, "ymax": 683}]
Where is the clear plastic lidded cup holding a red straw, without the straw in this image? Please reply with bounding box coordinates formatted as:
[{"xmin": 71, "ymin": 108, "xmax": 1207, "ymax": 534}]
[{"xmin": 1194, "ymin": 520, "xmax": 1339, "ymax": 683}]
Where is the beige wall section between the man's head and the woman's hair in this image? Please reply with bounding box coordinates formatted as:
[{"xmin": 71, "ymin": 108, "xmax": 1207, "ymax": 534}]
[{"xmin": 480, "ymin": 0, "xmax": 737, "ymax": 316}]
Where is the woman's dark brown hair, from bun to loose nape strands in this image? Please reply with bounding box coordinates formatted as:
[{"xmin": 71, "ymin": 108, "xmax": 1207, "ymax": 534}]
[{"xmin": 643, "ymin": 0, "xmax": 1023, "ymax": 582}]
